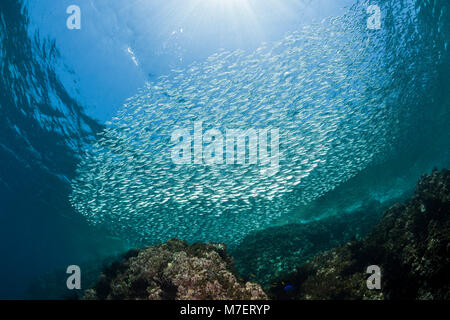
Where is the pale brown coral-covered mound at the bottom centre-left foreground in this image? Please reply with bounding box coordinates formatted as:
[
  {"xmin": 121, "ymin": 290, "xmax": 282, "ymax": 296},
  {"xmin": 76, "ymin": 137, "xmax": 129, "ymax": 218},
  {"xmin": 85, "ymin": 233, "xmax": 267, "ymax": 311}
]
[{"xmin": 84, "ymin": 239, "xmax": 267, "ymax": 300}]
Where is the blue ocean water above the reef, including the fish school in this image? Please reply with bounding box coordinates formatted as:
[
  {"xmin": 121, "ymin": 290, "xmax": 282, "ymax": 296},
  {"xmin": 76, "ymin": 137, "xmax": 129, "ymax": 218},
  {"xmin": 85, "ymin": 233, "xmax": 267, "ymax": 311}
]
[{"xmin": 0, "ymin": 0, "xmax": 450, "ymax": 298}]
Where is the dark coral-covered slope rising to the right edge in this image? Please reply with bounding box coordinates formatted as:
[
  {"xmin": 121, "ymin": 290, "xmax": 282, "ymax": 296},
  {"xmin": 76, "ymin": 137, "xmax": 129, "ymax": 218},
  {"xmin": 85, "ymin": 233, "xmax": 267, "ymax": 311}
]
[{"xmin": 270, "ymin": 170, "xmax": 450, "ymax": 300}]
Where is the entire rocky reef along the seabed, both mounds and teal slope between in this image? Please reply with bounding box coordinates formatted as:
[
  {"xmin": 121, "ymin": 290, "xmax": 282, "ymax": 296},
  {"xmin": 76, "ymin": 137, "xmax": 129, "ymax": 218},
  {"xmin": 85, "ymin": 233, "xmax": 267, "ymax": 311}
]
[{"xmin": 55, "ymin": 170, "xmax": 450, "ymax": 300}]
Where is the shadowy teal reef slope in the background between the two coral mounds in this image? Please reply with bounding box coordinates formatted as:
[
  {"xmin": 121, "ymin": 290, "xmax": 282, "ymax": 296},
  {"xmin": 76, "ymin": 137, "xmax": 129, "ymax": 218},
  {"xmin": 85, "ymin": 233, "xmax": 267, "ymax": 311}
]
[{"xmin": 230, "ymin": 201, "xmax": 385, "ymax": 288}]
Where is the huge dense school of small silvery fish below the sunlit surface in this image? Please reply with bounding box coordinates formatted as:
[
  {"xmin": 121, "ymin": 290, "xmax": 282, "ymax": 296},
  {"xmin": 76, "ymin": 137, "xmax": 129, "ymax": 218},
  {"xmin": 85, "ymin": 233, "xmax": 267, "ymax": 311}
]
[{"xmin": 71, "ymin": 1, "xmax": 446, "ymax": 244}]
